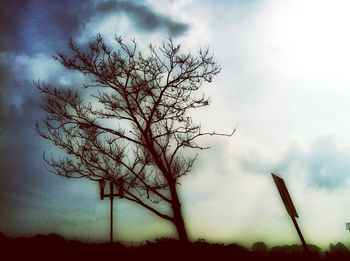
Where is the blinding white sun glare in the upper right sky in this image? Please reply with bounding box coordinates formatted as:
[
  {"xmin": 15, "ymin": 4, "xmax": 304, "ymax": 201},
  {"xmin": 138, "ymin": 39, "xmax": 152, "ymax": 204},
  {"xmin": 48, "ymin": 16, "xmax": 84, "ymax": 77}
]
[{"xmin": 259, "ymin": 0, "xmax": 350, "ymax": 84}]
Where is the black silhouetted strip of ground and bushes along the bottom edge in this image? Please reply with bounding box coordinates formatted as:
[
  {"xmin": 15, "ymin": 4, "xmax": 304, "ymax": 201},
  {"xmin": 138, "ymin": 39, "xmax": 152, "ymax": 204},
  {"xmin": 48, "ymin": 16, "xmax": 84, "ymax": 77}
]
[{"xmin": 0, "ymin": 233, "xmax": 350, "ymax": 261}]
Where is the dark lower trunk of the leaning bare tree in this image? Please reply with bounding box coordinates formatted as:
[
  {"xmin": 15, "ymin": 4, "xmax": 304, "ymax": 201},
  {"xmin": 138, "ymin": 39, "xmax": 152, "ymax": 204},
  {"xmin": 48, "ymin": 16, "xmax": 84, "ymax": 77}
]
[{"xmin": 170, "ymin": 184, "xmax": 189, "ymax": 243}]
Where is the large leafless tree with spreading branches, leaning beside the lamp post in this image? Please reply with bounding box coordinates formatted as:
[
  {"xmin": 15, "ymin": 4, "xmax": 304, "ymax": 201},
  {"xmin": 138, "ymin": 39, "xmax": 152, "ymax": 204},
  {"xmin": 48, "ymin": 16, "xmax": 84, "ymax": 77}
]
[{"xmin": 36, "ymin": 35, "xmax": 234, "ymax": 242}]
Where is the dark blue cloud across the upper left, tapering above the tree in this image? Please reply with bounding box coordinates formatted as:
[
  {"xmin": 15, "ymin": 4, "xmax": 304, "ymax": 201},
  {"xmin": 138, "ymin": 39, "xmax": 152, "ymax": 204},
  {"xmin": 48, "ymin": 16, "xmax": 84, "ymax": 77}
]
[{"xmin": 0, "ymin": 0, "xmax": 189, "ymax": 54}]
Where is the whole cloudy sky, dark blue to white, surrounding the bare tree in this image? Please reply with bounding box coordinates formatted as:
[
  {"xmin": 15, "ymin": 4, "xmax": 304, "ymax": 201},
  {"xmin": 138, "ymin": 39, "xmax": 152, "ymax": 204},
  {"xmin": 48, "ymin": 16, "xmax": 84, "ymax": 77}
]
[{"xmin": 0, "ymin": 0, "xmax": 350, "ymax": 248}]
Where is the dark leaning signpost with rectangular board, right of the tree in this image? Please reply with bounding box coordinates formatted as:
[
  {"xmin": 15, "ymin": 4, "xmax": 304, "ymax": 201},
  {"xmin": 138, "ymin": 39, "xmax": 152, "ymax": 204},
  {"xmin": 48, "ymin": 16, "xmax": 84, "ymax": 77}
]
[{"xmin": 271, "ymin": 173, "xmax": 310, "ymax": 254}]
